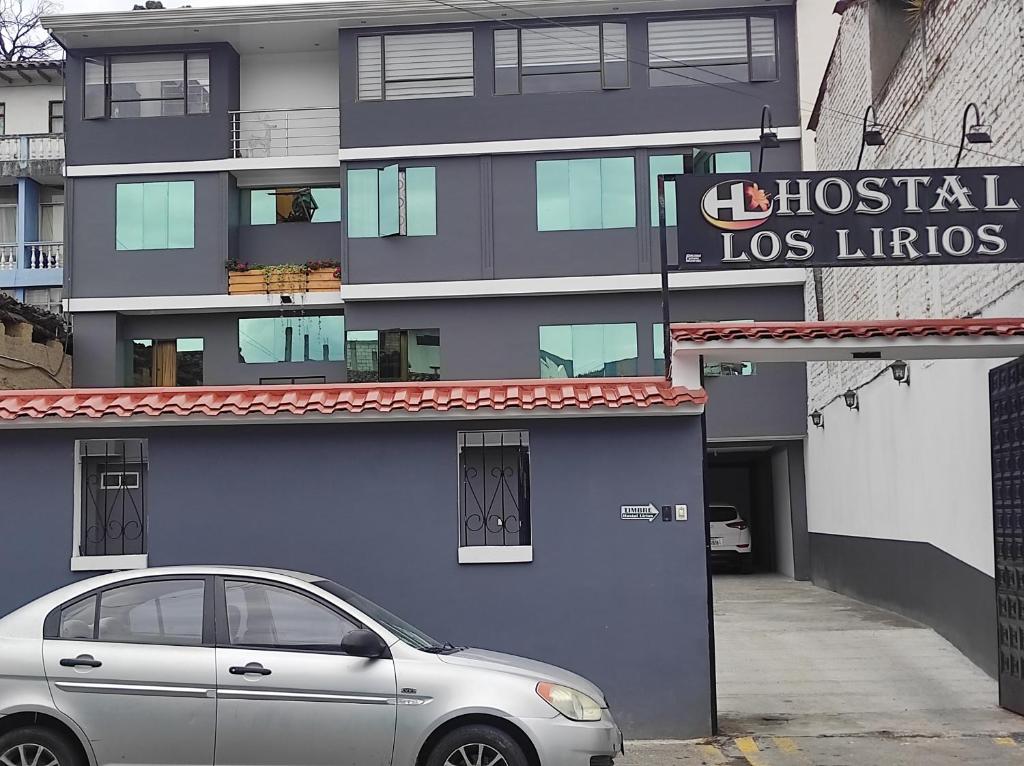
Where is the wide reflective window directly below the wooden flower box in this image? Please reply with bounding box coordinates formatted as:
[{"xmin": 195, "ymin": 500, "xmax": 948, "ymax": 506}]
[{"xmin": 239, "ymin": 315, "xmax": 345, "ymax": 365}]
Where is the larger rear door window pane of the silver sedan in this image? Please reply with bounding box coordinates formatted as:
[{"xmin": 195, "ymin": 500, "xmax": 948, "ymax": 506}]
[{"xmin": 96, "ymin": 580, "xmax": 205, "ymax": 644}]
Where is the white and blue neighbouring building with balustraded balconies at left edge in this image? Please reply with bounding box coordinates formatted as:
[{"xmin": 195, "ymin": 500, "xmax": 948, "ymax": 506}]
[{"xmin": 0, "ymin": 61, "xmax": 65, "ymax": 311}]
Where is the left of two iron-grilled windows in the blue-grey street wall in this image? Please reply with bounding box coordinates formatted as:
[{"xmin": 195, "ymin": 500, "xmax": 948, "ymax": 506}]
[{"xmin": 76, "ymin": 439, "xmax": 150, "ymax": 556}]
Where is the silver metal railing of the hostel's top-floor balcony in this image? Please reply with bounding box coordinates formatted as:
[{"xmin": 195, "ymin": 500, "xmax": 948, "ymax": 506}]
[{"xmin": 231, "ymin": 107, "xmax": 340, "ymax": 158}]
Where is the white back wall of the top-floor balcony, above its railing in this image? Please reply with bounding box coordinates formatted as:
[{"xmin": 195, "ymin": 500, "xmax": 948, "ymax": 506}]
[{"xmin": 239, "ymin": 50, "xmax": 339, "ymax": 110}]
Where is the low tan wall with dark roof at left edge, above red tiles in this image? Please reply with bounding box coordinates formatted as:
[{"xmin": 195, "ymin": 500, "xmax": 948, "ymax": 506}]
[{"xmin": 0, "ymin": 295, "xmax": 71, "ymax": 390}]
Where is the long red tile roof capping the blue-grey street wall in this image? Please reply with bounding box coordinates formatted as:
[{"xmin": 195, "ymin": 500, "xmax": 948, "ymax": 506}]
[{"xmin": 0, "ymin": 378, "xmax": 707, "ymax": 424}]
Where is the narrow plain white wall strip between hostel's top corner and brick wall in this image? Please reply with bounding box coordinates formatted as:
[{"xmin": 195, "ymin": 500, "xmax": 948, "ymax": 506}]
[{"xmin": 797, "ymin": 0, "xmax": 840, "ymax": 170}]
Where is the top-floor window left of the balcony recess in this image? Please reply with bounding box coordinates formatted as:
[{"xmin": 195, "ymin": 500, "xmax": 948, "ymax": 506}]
[{"xmin": 82, "ymin": 52, "xmax": 210, "ymax": 120}]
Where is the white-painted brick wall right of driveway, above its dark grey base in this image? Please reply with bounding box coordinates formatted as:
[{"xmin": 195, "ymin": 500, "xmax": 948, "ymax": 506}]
[{"xmin": 805, "ymin": 0, "xmax": 1024, "ymax": 576}]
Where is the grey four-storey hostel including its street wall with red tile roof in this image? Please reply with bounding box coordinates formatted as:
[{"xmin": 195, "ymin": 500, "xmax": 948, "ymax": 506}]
[{"xmin": 0, "ymin": 0, "xmax": 809, "ymax": 736}]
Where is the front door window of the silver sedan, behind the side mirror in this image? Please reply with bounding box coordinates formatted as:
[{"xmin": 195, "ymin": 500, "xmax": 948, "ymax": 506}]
[{"xmin": 224, "ymin": 581, "xmax": 358, "ymax": 650}]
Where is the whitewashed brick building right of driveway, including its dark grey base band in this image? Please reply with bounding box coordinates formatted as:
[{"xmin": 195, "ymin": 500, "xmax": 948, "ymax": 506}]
[{"xmin": 807, "ymin": 0, "xmax": 1024, "ymax": 673}]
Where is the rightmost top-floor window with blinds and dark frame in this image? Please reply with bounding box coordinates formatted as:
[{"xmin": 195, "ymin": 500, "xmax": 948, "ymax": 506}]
[{"xmin": 647, "ymin": 15, "xmax": 778, "ymax": 87}]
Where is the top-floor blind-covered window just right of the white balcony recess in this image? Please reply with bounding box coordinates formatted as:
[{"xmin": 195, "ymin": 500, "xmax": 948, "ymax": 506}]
[{"xmin": 356, "ymin": 32, "xmax": 473, "ymax": 101}]
